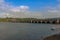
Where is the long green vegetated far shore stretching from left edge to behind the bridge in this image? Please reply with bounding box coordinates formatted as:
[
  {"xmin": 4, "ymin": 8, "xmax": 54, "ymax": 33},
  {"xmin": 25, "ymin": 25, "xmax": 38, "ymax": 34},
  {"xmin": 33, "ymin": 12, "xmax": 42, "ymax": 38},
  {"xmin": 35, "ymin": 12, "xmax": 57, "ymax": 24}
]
[{"xmin": 0, "ymin": 17, "xmax": 57, "ymax": 23}]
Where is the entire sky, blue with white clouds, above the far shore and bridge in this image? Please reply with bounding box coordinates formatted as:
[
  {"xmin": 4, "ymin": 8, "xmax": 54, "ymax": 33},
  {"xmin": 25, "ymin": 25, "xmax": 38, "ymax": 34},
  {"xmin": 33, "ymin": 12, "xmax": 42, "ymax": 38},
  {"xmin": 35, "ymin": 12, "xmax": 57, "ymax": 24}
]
[{"xmin": 0, "ymin": 0, "xmax": 60, "ymax": 18}]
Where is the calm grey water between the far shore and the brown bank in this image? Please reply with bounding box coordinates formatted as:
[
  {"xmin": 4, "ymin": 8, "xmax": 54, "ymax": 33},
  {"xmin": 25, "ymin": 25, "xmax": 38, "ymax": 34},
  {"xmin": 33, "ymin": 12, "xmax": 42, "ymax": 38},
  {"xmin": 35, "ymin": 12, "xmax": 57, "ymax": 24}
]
[{"xmin": 0, "ymin": 23, "xmax": 60, "ymax": 40}]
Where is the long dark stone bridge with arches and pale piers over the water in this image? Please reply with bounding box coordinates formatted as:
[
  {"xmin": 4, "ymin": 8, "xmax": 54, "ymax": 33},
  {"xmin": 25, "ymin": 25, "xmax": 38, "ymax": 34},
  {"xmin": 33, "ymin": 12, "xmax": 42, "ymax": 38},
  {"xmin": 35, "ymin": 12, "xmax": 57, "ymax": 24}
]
[{"xmin": 26, "ymin": 19, "xmax": 60, "ymax": 24}]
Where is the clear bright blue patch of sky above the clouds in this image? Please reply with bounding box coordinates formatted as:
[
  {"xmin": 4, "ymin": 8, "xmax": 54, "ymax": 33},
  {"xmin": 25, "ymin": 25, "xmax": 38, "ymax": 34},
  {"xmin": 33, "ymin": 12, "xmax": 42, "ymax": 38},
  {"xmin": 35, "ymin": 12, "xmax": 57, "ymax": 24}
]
[{"xmin": 6, "ymin": 0, "xmax": 59, "ymax": 11}]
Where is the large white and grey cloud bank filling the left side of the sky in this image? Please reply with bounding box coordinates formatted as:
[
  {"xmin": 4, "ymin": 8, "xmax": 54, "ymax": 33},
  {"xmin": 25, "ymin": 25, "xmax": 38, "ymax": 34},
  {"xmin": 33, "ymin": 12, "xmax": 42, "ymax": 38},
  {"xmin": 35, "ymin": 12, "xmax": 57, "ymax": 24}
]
[{"xmin": 0, "ymin": 0, "xmax": 42, "ymax": 18}]
